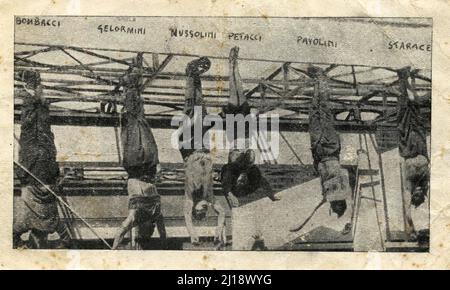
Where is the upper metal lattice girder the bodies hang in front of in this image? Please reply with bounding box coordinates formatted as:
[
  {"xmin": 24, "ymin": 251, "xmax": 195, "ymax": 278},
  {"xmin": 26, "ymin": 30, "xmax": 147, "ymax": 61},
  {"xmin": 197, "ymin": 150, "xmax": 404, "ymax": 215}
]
[{"xmin": 15, "ymin": 46, "xmax": 431, "ymax": 131}]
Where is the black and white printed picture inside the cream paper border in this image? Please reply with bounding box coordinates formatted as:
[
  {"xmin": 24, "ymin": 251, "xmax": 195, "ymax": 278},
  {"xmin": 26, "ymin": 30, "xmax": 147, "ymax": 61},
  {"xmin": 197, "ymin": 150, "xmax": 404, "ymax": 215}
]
[{"xmin": 11, "ymin": 15, "xmax": 430, "ymax": 253}]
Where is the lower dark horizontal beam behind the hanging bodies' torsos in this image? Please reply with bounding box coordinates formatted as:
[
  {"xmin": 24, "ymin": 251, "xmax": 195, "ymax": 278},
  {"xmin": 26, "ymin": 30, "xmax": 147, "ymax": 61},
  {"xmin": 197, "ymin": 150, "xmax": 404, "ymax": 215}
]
[{"xmin": 14, "ymin": 162, "xmax": 314, "ymax": 196}]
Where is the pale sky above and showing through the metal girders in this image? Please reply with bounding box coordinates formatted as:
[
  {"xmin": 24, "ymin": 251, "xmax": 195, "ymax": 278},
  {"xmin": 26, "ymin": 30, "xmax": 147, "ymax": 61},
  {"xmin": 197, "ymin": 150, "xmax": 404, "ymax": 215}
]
[{"xmin": 15, "ymin": 17, "xmax": 431, "ymax": 164}]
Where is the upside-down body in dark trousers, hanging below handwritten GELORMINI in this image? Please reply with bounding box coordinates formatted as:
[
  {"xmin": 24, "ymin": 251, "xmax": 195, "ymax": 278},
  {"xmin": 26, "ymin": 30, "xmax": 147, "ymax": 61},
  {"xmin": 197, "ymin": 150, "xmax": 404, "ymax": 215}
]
[{"xmin": 113, "ymin": 54, "xmax": 166, "ymax": 249}]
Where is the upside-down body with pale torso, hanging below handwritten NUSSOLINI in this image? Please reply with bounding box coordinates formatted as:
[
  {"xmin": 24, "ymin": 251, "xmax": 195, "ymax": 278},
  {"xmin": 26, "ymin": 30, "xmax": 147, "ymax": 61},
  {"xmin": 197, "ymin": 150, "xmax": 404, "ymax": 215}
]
[{"xmin": 179, "ymin": 57, "xmax": 226, "ymax": 248}]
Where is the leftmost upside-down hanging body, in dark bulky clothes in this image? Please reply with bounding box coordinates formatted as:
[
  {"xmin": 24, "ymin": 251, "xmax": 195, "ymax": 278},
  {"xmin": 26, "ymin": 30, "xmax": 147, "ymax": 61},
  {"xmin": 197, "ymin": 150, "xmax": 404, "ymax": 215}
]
[{"xmin": 13, "ymin": 71, "xmax": 71, "ymax": 248}]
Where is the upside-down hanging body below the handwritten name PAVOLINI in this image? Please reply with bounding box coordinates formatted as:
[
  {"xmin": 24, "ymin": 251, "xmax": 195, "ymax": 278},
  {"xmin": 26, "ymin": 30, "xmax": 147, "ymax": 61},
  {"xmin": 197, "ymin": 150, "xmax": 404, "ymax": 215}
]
[{"xmin": 308, "ymin": 66, "xmax": 351, "ymax": 233}]
